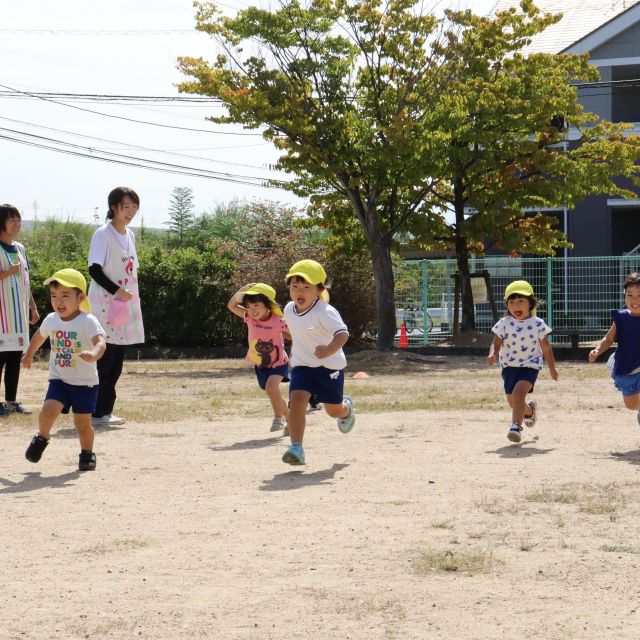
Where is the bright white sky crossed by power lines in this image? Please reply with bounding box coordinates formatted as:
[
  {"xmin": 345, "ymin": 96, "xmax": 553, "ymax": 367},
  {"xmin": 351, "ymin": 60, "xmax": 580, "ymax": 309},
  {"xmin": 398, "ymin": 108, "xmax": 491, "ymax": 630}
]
[{"xmin": 0, "ymin": 0, "xmax": 494, "ymax": 228}]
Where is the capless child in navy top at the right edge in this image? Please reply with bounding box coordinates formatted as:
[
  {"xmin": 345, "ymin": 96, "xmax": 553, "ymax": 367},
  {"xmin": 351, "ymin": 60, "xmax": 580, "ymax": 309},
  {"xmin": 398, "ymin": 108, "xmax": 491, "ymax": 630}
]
[{"xmin": 589, "ymin": 272, "xmax": 640, "ymax": 423}]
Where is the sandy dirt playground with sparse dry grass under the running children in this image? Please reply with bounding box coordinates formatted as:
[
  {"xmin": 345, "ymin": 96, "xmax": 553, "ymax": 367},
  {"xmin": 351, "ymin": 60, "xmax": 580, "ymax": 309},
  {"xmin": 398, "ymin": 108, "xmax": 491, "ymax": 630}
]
[{"xmin": 0, "ymin": 353, "xmax": 640, "ymax": 640}]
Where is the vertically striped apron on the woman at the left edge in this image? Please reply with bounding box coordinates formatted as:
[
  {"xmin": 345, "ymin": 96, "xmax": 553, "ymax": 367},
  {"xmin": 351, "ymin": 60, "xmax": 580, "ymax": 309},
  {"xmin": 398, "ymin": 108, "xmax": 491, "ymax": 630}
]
[{"xmin": 0, "ymin": 242, "xmax": 31, "ymax": 351}]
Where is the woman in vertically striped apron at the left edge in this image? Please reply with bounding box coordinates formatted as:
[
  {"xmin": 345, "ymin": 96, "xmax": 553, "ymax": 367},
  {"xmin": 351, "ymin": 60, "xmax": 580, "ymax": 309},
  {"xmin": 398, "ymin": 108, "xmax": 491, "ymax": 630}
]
[{"xmin": 0, "ymin": 204, "xmax": 40, "ymax": 415}]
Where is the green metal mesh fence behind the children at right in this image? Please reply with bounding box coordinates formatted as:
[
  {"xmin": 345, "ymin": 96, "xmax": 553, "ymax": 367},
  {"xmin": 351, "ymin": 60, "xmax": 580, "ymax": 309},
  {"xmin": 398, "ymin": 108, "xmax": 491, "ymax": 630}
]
[{"xmin": 395, "ymin": 254, "xmax": 640, "ymax": 346}]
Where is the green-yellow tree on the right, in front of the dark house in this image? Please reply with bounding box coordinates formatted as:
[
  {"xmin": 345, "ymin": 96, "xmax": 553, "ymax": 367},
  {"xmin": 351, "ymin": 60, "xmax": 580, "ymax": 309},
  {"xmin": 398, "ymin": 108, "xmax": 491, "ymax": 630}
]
[{"xmin": 404, "ymin": 1, "xmax": 640, "ymax": 330}]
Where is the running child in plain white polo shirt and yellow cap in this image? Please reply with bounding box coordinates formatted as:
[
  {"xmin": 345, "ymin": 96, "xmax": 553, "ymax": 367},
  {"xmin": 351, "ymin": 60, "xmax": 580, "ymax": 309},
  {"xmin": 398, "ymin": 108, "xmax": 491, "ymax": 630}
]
[{"xmin": 282, "ymin": 260, "xmax": 355, "ymax": 465}]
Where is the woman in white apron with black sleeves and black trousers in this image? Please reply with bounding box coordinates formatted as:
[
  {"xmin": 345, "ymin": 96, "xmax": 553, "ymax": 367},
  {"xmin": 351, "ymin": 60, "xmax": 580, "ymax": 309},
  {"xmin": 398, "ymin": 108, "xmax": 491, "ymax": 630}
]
[{"xmin": 89, "ymin": 187, "xmax": 144, "ymax": 426}]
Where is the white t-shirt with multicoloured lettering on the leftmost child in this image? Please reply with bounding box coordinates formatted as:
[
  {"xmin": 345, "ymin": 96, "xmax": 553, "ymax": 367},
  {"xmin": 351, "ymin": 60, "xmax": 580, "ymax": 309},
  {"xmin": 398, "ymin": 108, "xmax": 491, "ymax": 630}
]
[{"xmin": 40, "ymin": 313, "xmax": 104, "ymax": 387}]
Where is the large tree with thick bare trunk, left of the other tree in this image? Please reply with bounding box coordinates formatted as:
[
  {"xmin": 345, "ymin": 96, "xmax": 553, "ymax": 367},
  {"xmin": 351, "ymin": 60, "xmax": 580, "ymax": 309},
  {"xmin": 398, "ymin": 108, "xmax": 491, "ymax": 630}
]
[{"xmin": 175, "ymin": 0, "xmax": 439, "ymax": 348}]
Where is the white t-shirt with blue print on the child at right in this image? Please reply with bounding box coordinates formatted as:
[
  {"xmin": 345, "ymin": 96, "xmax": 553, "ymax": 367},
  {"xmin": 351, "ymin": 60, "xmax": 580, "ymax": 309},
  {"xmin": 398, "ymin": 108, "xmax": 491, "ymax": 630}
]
[{"xmin": 492, "ymin": 316, "xmax": 551, "ymax": 370}]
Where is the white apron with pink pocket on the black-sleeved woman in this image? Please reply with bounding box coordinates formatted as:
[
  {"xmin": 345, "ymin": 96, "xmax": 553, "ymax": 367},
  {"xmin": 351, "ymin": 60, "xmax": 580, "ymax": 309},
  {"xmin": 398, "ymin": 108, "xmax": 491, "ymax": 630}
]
[{"xmin": 89, "ymin": 224, "xmax": 144, "ymax": 344}]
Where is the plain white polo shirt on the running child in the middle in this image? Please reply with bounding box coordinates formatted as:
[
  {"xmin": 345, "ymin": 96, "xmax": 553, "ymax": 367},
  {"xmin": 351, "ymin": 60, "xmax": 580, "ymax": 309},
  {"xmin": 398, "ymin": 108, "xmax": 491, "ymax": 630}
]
[{"xmin": 284, "ymin": 298, "xmax": 349, "ymax": 369}]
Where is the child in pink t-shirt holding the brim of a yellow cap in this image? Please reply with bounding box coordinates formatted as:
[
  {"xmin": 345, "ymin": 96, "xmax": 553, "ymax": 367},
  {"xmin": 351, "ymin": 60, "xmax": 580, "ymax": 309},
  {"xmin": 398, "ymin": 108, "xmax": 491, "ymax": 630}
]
[{"xmin": 227, "ymin": 282, "xmax": 289, "ymax": 435}]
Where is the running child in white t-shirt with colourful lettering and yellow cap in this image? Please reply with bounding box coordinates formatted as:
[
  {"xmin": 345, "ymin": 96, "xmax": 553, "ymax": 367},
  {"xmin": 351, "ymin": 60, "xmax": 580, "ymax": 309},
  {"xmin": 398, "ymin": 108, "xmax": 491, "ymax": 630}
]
[{"xmin": 22, "ymin": 269, "xmax": 106, "ymax": 471}]
